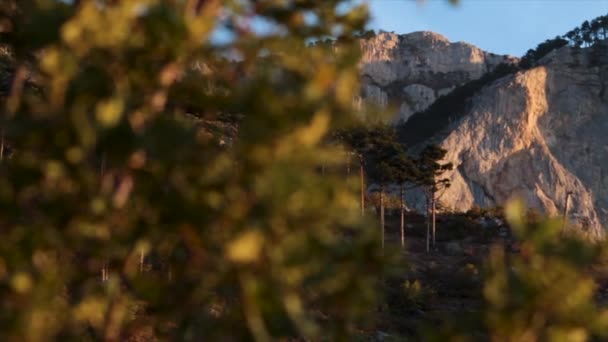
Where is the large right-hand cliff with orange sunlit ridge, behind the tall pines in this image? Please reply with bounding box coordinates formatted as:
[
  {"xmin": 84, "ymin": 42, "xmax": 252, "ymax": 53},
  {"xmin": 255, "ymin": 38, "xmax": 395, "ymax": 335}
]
[{"xmin": 439, "ymin": 47, "xmax": 608, "ymax": 237}]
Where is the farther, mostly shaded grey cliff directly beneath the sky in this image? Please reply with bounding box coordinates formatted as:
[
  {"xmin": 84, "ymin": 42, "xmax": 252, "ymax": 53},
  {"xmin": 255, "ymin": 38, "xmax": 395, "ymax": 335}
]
[{"xmin": 360, "ymin": 32, "xmax": 517, "ymax": 122}]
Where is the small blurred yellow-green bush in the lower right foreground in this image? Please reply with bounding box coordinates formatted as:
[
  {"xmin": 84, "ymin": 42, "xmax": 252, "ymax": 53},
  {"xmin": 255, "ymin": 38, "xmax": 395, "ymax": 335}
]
[{"xmin": 432, "ymin": 201, "xmax": 608, "ymax": 341}]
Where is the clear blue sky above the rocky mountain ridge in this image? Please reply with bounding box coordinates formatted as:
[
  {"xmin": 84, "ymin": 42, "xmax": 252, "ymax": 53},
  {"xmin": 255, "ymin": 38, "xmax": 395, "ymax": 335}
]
[{"xmin": 369, "ymin": 0, "xmax": 608, "ymax": 56}]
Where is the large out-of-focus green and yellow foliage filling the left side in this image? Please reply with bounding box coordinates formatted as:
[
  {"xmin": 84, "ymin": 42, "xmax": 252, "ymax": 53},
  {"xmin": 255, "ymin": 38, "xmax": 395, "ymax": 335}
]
[{"xmin": 0, "ymin": 0, "xmax": 380, "ymax": 341}]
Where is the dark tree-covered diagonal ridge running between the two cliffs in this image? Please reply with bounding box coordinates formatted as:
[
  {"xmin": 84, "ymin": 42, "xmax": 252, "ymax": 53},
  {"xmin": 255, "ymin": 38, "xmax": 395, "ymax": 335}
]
[{"xmin": 396, "ymin": 15, "xmax": 608, "ymax": 146}]
